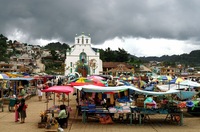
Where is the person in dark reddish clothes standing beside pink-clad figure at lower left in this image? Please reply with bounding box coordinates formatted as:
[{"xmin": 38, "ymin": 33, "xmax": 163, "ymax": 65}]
[{"xmin": 17, "ymin": 98, "xmax": 27, "ymax": 123}]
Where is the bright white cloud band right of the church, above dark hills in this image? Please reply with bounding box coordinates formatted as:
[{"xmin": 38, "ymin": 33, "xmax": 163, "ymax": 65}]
[{"xmin": 92, "ymin": 37, "xmax": 200, "ymax": 57}]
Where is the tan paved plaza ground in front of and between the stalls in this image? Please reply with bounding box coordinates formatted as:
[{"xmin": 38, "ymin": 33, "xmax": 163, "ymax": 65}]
[{"xmin": 0, "ymin": 95, "xmax": 200, "ymax": 132}]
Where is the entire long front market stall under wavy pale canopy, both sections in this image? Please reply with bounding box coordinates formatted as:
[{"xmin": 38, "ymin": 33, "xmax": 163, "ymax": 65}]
[{"xmin": 74, "ymin": 85, "xmax": 183, "ymax": 125}]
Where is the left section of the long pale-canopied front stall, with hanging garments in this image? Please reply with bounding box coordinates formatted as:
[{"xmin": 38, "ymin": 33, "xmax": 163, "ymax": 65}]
[{"xmin": 74, "ymin": 85, "xmax": 131, "ymax": 123}]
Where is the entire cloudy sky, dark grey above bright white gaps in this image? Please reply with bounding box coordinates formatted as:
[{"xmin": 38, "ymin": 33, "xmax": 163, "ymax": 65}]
[{"xmin": 0, "ymin": 0, "xmax": 200, "ymax": 57}]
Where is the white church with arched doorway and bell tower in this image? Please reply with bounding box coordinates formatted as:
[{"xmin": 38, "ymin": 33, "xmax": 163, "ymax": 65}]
[{"xmin": 65, "ymin": 33, "xmax": 103, "ymax": 77}]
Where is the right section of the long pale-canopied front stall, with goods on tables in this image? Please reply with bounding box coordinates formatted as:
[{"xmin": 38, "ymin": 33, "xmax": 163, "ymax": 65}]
[{"xmin": 126, "ymin": 86, "xmax": 186, "ymax": 125}]
